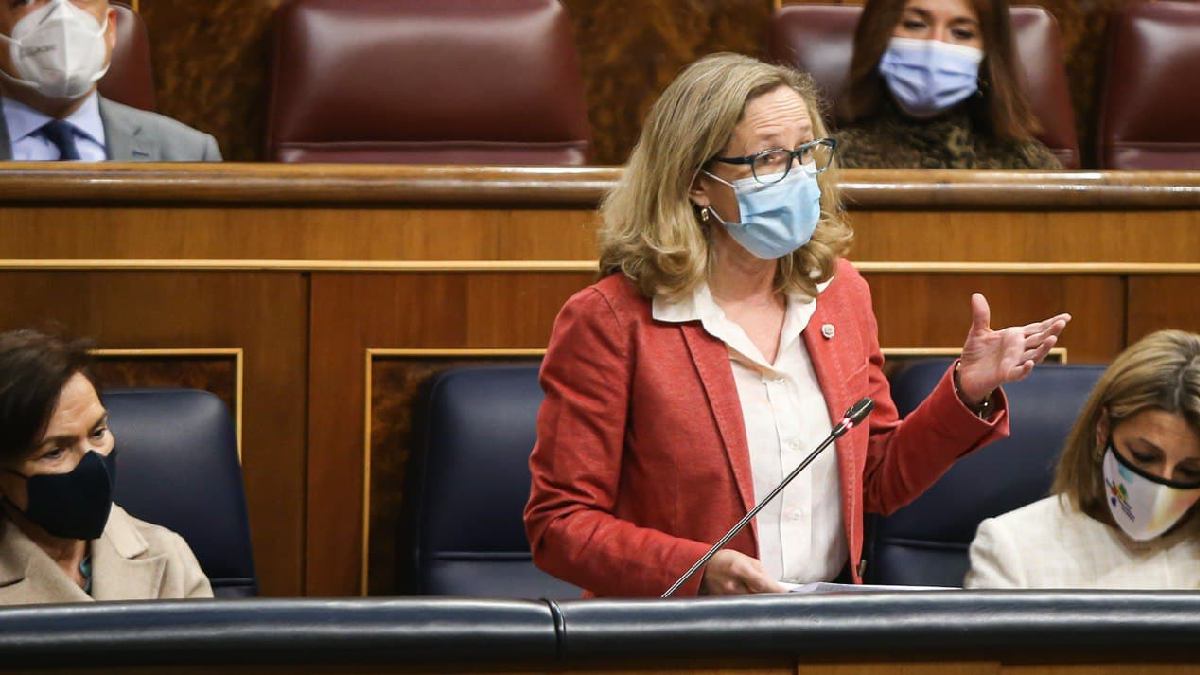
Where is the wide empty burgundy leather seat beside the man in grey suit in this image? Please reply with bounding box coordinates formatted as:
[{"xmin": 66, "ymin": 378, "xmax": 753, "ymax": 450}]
[{"xmin": 266, "ymin": 0, "xmax": 590, "ymax": 165}]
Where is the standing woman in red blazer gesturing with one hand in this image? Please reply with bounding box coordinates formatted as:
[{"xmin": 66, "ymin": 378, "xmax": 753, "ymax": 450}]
[{"xmin": 524, "ymin": 54, "xmax": 1069, "ymax": 596}]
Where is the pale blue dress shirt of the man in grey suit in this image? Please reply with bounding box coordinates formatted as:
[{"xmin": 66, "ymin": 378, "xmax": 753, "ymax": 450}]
[{"xmin": 2, "ymin": 91, "xmax": 108, "ymax": 162}]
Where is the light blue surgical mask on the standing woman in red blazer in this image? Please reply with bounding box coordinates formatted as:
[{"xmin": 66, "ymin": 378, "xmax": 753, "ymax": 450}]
[{"xmin": 704, "ymin": 167, "xmax": 821, "ymax": 261}]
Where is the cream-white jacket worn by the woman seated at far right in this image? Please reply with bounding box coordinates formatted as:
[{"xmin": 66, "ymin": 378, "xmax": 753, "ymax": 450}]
[{"xmin": 964, "ymin": 495, "xmax": 1200, "ymax": 591}]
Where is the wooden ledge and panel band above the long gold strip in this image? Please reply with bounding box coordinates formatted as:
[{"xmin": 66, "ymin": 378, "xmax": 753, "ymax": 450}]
[{"xmin": 0, "ymin": 165, "xmax": 1200, "ymax": 269}]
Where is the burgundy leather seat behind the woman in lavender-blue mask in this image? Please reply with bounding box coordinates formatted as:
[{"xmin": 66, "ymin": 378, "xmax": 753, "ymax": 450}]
[{"xmin": 769, "ymin": 5, "xmax": 1079, "ymax": 168}]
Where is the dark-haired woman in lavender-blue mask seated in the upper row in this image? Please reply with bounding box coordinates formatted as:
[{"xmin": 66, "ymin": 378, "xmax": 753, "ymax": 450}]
[{"xmin": 835, "ymin": 0, "xmax": 1062, "ymax": 169}]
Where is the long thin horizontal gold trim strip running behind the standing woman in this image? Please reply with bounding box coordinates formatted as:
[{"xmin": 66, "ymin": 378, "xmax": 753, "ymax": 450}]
[{"xmin": 7, "ymin": 258, "xmax": 1200, "ymax": 275}]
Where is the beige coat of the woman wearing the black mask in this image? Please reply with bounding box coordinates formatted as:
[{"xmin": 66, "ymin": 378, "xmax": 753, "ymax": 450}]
[{"xmin": 0, "ymin": 504, "xmax": 212, "ymax": 605}]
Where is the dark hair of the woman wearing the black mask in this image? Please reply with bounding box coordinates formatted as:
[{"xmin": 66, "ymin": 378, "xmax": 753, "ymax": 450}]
[{"xmin": 0, "ymin": 330, "xmax": 96, "ymax": 464}]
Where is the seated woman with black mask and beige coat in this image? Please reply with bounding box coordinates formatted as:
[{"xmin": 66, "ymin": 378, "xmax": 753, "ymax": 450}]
[{"xmin": 0, "ymin": 330, "xmax": 212, "ymax": 604}]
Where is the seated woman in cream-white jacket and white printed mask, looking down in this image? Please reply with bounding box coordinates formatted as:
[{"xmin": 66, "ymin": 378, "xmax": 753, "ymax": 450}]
[{"xmin": 966, "ymin": 330, "xmax": 1200, "ymax": 591}]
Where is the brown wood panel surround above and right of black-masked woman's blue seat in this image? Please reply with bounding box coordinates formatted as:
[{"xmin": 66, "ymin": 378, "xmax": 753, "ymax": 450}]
[{"xmin": 0, "ymin": 271, "xmax": 307, "ymax": 596}]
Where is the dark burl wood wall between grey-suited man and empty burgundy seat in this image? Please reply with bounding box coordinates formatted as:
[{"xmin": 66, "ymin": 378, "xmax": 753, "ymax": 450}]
[{"xmin": 138, "ymin": 0, "xmax": 284, "ymax": 161}]
